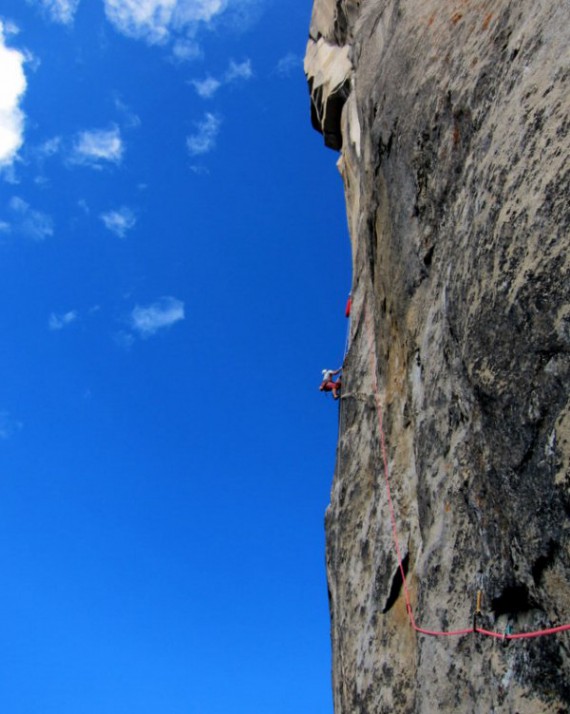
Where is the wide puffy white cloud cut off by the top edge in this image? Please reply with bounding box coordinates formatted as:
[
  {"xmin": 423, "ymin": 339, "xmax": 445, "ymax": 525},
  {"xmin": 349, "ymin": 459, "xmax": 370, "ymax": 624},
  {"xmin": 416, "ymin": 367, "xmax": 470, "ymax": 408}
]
[{"xmin": 105, "ymin": 0, "xmax": 226, "ymax": 44}]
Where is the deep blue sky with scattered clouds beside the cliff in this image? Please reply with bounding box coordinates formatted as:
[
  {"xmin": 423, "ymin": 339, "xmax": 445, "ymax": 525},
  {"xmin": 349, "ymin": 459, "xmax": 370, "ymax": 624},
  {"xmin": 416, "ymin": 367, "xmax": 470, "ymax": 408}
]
[{"xmin": 0, "ymin": 0, "xmax": 350, "ymax": 714}]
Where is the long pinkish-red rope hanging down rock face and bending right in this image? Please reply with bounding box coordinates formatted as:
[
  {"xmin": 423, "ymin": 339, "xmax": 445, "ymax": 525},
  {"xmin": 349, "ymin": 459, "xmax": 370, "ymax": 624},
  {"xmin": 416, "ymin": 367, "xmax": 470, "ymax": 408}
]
[{"xmin": 364, "ymin": 307, "xmax": 570, "ymax": 640}]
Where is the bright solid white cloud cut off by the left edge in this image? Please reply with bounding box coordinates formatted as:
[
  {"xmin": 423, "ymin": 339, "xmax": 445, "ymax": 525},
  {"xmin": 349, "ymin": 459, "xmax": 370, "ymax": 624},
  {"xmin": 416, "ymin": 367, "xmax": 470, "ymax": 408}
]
[{"xmin": 0, "ymin": 20, "xmax": 27, "ymax": 168}]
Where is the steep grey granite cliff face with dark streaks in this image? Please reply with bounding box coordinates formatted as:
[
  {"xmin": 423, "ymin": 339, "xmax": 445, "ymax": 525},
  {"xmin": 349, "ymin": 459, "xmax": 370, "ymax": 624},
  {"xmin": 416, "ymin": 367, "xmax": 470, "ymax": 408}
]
[{"xmin": 306, "ymin": 0, "xmax": 570, "ymax": 714}]
